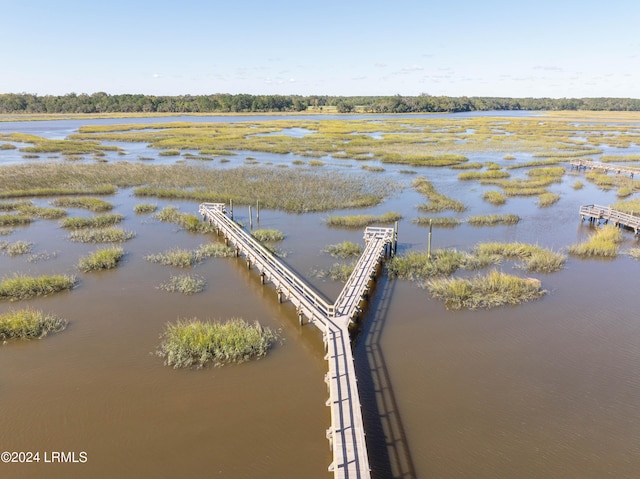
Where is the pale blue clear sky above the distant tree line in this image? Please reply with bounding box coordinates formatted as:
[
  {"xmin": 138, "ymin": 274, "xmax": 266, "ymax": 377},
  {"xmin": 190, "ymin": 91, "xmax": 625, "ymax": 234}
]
[{"xmin": 0, "ymin": 0, "xmax": 640, "ymax": 98}]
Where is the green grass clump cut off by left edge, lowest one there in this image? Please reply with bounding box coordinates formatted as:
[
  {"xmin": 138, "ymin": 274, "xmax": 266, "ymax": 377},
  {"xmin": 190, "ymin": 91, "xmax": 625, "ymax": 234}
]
[{"xmin": 0, "ymin": 308, "xmax": 67, "ymax": 340}]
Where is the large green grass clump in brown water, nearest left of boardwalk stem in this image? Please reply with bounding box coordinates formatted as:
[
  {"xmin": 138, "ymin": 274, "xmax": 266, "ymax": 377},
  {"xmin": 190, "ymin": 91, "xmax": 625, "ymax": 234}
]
[{"xmin": 157, "ymin": 318, "xmax": 277, "ymax": 368}]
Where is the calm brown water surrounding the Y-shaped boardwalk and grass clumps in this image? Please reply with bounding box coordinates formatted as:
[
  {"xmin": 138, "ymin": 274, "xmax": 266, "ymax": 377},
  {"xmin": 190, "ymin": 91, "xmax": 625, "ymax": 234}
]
[{"xmin": 0, "ymin": 116, "xmax": 640, "ymax": 479}]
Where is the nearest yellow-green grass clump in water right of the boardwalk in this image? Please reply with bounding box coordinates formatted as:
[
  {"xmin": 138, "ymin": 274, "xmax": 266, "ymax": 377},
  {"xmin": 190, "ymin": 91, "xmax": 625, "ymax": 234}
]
[{"xmin": 426, "ymin": 270, "xmax": 546, "ymax": 310}]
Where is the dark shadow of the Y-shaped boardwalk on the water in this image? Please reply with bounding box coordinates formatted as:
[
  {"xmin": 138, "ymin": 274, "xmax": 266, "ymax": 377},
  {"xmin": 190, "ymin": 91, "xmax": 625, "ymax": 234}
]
[{"xmin": 353, "ymin": 274, "xmax": 417, "ymax": 479}]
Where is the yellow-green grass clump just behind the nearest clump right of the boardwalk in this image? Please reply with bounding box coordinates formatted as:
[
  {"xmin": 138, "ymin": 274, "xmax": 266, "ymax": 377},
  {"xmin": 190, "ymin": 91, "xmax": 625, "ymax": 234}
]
[{"xmin": 474, "ymin": 242, "xmax": 567, "ymax": 273}]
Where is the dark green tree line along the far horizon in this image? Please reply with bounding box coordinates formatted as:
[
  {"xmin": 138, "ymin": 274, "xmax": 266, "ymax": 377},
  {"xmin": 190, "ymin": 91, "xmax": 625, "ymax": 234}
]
[{"xmin": 0, "ymin": 92, "xmax": 640, "ymax": 113}]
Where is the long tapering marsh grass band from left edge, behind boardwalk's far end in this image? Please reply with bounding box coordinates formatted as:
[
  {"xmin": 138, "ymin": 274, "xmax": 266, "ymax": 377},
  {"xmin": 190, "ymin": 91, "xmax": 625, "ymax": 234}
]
[{"xmin": 0, "ymin": 162, "xmax": 400, "ymax": 213}]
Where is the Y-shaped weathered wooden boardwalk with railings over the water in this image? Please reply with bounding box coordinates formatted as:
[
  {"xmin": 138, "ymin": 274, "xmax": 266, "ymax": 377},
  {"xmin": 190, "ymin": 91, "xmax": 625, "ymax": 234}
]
[{"xmin": 200, "ymin": 203, "xmax": 397, "ymax": 479}]
